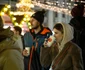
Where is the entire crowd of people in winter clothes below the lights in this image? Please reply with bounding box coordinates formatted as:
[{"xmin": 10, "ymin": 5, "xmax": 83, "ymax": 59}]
[{"xmin": 0, "ymin": 4, "xmax": 85, "ymax": 70}]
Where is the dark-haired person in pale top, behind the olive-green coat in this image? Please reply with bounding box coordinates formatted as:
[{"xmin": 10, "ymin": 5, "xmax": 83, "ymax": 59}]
[{"xmin": 13, "ymin": 26, "xmax": 24, "ymax": 50}]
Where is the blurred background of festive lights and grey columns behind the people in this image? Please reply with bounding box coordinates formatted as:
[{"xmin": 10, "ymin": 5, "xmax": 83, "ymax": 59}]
[{"xmin": 0, "ymin": 0, "xmax": 85, "ymax": 34}]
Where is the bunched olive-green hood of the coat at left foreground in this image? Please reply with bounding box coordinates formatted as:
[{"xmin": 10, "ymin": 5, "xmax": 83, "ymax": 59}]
[{"xmin": 0, "ymin": 28, "xmax": 21, "ymax": 52}]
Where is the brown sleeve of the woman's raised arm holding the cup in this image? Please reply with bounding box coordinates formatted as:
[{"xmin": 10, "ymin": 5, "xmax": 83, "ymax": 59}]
[{"xmin": 40, "ymin": 46, "xmax": 58, "ymax": 67}]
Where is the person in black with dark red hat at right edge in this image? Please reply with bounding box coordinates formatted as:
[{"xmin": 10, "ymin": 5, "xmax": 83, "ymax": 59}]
[{"xmin": 69, "ymin": 4, "xmax": 85, "ymax": 67}]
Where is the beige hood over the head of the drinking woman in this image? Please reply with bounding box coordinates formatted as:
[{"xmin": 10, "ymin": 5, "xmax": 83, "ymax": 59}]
[{"xmin": 58, "ymin": 23, "xmax": 74, "ymax": 51}]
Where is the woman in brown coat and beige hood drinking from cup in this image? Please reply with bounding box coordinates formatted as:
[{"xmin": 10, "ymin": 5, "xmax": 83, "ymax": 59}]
[{"xmin": 40, "ymin": 23, "xmax": 84, "ymax": 70}]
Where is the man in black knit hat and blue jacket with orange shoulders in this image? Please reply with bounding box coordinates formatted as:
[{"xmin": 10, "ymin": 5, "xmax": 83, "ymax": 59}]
[{"xmin": 23, "ymin": 10, "xmax": 52, "ymax": 70}]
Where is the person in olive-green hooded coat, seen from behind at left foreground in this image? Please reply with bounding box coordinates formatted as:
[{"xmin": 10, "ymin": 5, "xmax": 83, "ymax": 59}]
[{"xmin": 0, "ymin": 16, "xmax": 24, "ymax": 70}]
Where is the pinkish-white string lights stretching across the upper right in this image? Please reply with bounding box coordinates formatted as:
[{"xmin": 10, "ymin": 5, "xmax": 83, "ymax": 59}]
[{"xmin": 32, "ymin": 0, "xmax": 85, "ymax": 15}]
